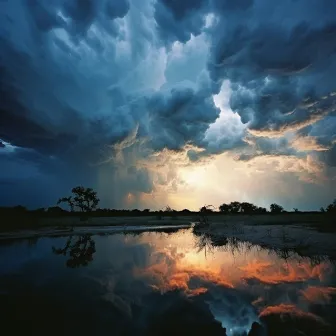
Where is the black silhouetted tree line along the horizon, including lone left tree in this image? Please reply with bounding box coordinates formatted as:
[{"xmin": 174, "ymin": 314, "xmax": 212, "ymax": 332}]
[{"xmin": 0, "ymin": 186, "xmax": 336, "ymax": 231}]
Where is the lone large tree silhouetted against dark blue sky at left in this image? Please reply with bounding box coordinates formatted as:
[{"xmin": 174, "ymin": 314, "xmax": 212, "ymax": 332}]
[{"xmin": 57, "ymin": 186, "xmax": 99, "ymax": 212}]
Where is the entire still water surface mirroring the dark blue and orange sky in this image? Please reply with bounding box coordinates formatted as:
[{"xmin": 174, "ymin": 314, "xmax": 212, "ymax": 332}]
[{"xmin": 0, "ymin": 229, "xmax": 336, "ymax": 336}]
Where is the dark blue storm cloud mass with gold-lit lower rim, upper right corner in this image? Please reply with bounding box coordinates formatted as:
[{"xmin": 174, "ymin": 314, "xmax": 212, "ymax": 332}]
[{"xmin": 209, "ymin": 1, "xmax": 336, "ymax": 134}]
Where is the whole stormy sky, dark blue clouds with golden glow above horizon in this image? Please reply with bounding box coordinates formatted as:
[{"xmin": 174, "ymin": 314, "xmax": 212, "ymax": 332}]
[{"xmin": 0, "ymin": 0, "xmax": 336, "ymax": 209}]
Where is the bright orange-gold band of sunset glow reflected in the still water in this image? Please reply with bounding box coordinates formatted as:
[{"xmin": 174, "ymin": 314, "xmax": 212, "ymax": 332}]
[{"xmin": 130, "ymin": 234, "xmax": 332, "ymax": 298}]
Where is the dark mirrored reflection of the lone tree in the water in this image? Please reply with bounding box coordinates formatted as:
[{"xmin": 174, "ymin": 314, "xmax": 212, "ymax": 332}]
[{"xmin": 52, "ymin": 234, "xmax": 96, "ymax": 268}]
